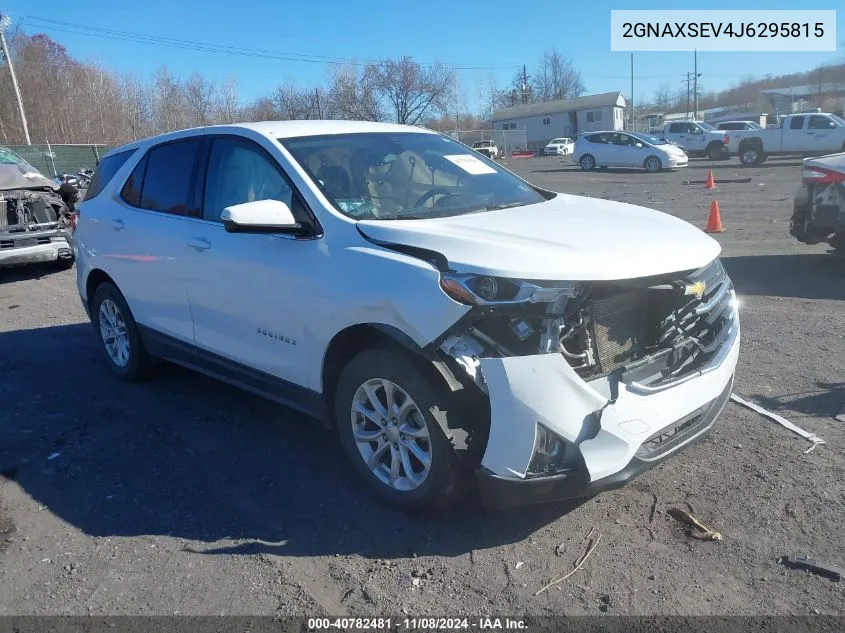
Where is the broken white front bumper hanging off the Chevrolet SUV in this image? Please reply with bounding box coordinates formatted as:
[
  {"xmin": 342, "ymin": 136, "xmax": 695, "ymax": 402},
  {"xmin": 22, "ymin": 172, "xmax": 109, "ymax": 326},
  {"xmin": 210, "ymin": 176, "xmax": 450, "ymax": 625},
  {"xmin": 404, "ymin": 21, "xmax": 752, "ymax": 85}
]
[{"xmin": 476, "ymin": 298, "xmax": 740, "ymax": 509}]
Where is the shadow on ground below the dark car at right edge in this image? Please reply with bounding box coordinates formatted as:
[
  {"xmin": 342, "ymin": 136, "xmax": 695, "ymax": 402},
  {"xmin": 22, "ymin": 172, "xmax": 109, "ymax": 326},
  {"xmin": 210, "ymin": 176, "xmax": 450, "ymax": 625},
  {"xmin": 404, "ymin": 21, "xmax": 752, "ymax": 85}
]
[{"xmin": 722, "ymin": 252, "xmax": 845, "ymax": 301}]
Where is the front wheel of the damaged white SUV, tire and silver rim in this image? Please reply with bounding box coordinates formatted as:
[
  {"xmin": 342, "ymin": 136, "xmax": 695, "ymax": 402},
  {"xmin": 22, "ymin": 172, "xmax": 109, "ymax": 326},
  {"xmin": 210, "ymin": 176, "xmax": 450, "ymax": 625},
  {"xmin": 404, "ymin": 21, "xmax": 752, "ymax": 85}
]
[{"xmin": 334, "ymin": 349, "xmax": 465, "ymax": 513}]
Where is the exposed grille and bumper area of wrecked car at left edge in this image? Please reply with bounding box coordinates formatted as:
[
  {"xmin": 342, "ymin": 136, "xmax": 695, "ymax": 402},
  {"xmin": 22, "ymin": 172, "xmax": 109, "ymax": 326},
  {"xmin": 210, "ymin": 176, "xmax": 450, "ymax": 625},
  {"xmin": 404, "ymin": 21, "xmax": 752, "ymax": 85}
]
[{"xmin": 0, "ymin": 187, "xmax": 74, "ymax": 266}]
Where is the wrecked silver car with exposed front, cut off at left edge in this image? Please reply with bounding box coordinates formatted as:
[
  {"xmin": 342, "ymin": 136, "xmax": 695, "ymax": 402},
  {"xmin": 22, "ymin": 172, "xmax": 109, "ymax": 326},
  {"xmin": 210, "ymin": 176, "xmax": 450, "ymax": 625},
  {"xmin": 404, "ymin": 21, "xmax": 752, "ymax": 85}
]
[{"xmin": 0, "ymin": 147, "xmax": 75, "ymax": 268}]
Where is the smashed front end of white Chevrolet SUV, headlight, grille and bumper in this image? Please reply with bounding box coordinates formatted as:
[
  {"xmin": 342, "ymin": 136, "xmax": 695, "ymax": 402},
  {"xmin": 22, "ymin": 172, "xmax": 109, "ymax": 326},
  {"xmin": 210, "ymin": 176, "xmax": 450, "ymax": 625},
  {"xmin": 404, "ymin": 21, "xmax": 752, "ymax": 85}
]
[{"xmin": 432, "ymin": 260, "xmax": 739, "ymax": 497}]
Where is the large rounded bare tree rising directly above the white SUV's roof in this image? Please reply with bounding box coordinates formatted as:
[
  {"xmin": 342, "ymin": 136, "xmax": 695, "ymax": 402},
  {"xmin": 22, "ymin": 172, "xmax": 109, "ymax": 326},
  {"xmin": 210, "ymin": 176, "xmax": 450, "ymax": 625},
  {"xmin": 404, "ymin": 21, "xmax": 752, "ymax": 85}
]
[{"xmin": 363, "ymin": 57, "xmax": 455, "ymax": 125}]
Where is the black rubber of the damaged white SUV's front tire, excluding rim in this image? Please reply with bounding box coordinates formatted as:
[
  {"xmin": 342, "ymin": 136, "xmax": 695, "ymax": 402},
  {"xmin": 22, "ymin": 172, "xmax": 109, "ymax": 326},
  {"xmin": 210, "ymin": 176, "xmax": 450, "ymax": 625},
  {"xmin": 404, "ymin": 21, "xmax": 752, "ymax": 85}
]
[{"xmin": 334, "ymin": 349, "xmax": 472, "ymax": 514}]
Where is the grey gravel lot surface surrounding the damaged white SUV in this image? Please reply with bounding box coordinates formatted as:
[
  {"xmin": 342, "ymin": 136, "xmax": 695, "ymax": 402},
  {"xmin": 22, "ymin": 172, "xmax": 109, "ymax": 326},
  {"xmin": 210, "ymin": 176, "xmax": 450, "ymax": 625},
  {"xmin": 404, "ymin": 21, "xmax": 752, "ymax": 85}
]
[{"xmin": 0, "ymin": 158, "xmax": 845, "ymax": 616}]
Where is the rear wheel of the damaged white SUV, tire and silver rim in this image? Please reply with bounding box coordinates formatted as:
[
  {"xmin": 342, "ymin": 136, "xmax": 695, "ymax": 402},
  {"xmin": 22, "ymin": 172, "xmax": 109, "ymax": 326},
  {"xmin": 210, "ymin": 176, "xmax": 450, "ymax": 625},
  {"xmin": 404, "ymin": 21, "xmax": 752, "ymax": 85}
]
[{"xmin": 91, "ymin": 282, "xmax": 152, "ymax": 382}]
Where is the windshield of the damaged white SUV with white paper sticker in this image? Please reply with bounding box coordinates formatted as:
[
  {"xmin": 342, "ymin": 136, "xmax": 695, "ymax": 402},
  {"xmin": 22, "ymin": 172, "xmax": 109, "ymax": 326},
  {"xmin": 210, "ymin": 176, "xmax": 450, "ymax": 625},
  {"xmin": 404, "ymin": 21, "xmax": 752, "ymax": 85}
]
[{"xmin": 279, "ymin": 132, "xmax": 545, "ymax": 220}]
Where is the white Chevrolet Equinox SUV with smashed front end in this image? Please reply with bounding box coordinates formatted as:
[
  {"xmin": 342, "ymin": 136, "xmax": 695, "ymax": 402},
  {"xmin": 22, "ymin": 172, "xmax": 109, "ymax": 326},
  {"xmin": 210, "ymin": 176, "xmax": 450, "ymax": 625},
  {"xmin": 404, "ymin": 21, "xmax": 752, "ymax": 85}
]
[{"xmin": 75, "ymin": 121, "xmax": 739, "ymax": 510}]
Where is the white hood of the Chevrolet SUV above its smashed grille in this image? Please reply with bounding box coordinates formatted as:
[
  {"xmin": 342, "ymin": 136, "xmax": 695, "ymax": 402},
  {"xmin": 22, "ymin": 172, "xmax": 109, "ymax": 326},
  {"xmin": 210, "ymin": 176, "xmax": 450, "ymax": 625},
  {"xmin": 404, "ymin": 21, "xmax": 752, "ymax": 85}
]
[{"xmin": 358, "ymin": 194, "xmax": 721, "ymax": 281}]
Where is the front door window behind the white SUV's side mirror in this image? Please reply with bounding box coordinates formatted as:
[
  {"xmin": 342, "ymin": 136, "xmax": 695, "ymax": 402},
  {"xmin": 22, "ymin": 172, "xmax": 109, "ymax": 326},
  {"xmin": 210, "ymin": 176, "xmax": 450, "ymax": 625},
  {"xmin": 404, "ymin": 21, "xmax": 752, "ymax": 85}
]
[{"xmin": 202, "ymin": 137, "xmax": 302, "ymax": 222}]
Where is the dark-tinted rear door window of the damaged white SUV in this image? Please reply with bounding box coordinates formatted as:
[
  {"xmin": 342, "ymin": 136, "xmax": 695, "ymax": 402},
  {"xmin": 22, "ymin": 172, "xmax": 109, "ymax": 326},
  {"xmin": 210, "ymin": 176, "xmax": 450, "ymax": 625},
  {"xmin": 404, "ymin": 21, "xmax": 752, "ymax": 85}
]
[{"xmin": 138, "ymin": 139, "xmax": 205, "ymax": 217}]
